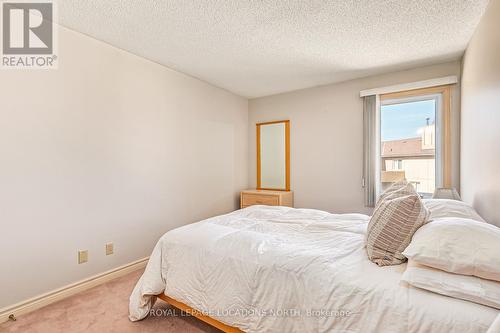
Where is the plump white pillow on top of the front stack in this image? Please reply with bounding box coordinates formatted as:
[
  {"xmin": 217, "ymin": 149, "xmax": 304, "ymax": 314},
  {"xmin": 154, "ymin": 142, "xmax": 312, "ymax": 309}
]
[{"xmin": 403, "ymin": 217, "xmax": 500, "ymax": 281}]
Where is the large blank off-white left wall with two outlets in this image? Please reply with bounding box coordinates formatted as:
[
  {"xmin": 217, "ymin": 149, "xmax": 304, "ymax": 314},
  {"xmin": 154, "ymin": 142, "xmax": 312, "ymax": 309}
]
[{"xmin": 0, "ymin": 22, "xmax": 248, "ymax": 308}]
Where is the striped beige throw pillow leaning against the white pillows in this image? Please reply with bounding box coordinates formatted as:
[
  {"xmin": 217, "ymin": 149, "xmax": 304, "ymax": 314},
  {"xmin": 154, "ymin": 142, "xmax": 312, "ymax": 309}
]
[{"xmin": 366, "ymin": 188, "xmax": 429, "ymax": 266}]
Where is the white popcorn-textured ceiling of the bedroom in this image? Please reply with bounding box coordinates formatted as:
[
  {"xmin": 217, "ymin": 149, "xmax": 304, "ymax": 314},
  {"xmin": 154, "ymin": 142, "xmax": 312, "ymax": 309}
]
[{"xmin": 58, "ymin": 0, "xmax": 488, "ymax": 98}]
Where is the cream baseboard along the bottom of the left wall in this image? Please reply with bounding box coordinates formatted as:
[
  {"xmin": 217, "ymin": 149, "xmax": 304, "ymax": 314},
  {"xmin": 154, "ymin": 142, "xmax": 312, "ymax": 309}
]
[{"xmin": 0, "ymin": 257, "xmax": 149, "ymax": 323}]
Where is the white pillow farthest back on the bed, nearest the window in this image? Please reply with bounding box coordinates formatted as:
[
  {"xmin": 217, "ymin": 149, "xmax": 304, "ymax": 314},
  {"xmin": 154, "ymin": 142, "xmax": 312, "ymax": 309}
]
[{"xmin": 422, "ymin": 199, "xmax": 484, "ymax": 222}]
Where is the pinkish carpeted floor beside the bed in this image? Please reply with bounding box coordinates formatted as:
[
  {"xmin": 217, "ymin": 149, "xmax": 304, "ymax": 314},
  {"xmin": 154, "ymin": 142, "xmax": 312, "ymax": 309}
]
[{"xmin": 0, "ymin": 270, "xmax": 220, "ymax": 333}]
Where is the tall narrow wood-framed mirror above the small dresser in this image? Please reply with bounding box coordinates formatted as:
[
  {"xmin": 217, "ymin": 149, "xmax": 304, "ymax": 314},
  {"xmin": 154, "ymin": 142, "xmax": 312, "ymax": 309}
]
[{"xmin": 256, "ymin": 120, "xmax": 290, "ymax": 191}]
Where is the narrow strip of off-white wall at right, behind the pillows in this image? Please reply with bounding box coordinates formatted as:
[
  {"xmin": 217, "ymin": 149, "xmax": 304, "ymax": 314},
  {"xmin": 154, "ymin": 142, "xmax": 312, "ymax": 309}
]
[{"xmin": 461, "ymin": 0, "xmax": 500, "ymax": 226}]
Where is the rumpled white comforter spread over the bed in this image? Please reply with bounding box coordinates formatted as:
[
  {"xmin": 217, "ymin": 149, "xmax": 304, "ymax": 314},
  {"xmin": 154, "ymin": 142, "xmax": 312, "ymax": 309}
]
[{"xmin": 130, "ymin": 206, "xmax": 499, "ymax": 333}]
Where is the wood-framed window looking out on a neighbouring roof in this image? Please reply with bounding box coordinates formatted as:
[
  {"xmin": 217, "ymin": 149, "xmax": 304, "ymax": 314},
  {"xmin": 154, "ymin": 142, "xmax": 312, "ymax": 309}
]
[{"xmin": 376, "ymin": 87, "xmax": 450, "ymax": 198}]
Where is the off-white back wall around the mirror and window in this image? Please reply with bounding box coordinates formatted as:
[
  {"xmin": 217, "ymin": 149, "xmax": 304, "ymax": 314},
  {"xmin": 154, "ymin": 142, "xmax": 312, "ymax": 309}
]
[{"xmin": 249, "ymin": 61, "xmax": 460, "ymax": 213}]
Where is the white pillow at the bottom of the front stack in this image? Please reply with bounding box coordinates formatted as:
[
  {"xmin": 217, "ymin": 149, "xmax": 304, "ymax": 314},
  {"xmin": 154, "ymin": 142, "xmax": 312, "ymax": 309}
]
[{"xmin": 401, "ymin": 261, "xmax": 500, "ymax": 309}]
